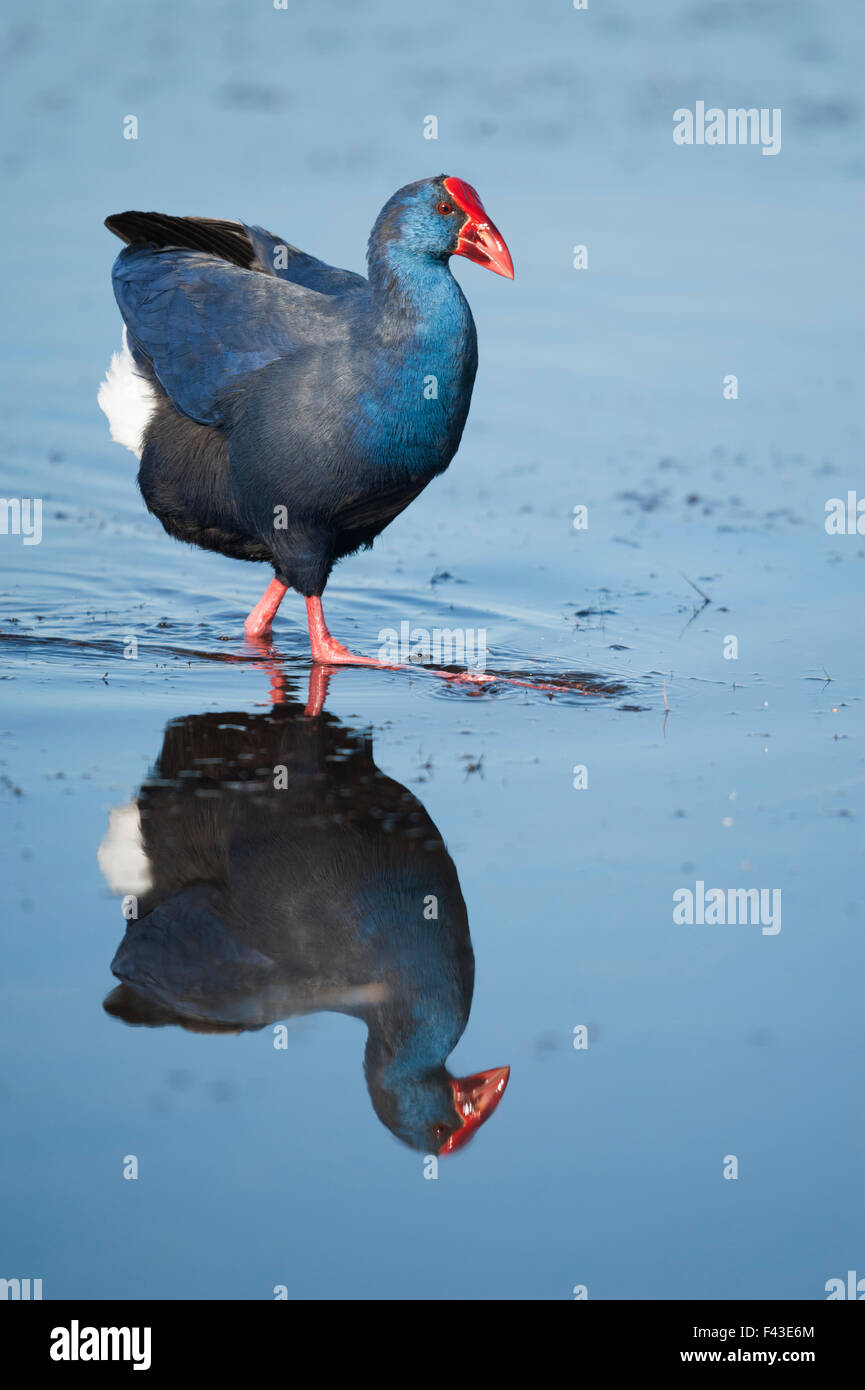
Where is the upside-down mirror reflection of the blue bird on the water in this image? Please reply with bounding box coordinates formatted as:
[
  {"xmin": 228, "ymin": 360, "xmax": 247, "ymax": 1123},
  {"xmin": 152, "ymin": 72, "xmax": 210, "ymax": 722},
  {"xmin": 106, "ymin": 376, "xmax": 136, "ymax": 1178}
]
[{"xmin": 99, "ymin": 699, "xmax": 510, "ymax": 1156}]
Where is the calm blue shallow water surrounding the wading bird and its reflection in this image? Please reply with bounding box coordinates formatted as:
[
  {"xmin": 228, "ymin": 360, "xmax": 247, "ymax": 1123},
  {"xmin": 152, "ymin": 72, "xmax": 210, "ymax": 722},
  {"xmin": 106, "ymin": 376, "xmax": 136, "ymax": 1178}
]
[{"xmin": 0, "ymin": 0, "xmax": 865, "ymax": 1298}]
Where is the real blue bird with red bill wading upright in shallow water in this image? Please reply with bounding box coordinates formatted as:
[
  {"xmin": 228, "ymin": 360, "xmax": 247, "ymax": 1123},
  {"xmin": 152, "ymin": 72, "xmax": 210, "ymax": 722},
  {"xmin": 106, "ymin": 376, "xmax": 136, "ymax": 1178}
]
[{"xmin": 99, "ymin": 174, "xmax": 513, "ymax": 666}]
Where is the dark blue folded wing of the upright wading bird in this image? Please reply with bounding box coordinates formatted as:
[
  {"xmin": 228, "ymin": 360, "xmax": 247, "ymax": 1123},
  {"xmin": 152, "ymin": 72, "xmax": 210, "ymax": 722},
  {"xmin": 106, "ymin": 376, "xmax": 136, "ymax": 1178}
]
[{"xmin": 113, "ymin": 247, "xmax": 349, "ymax": 424}]
